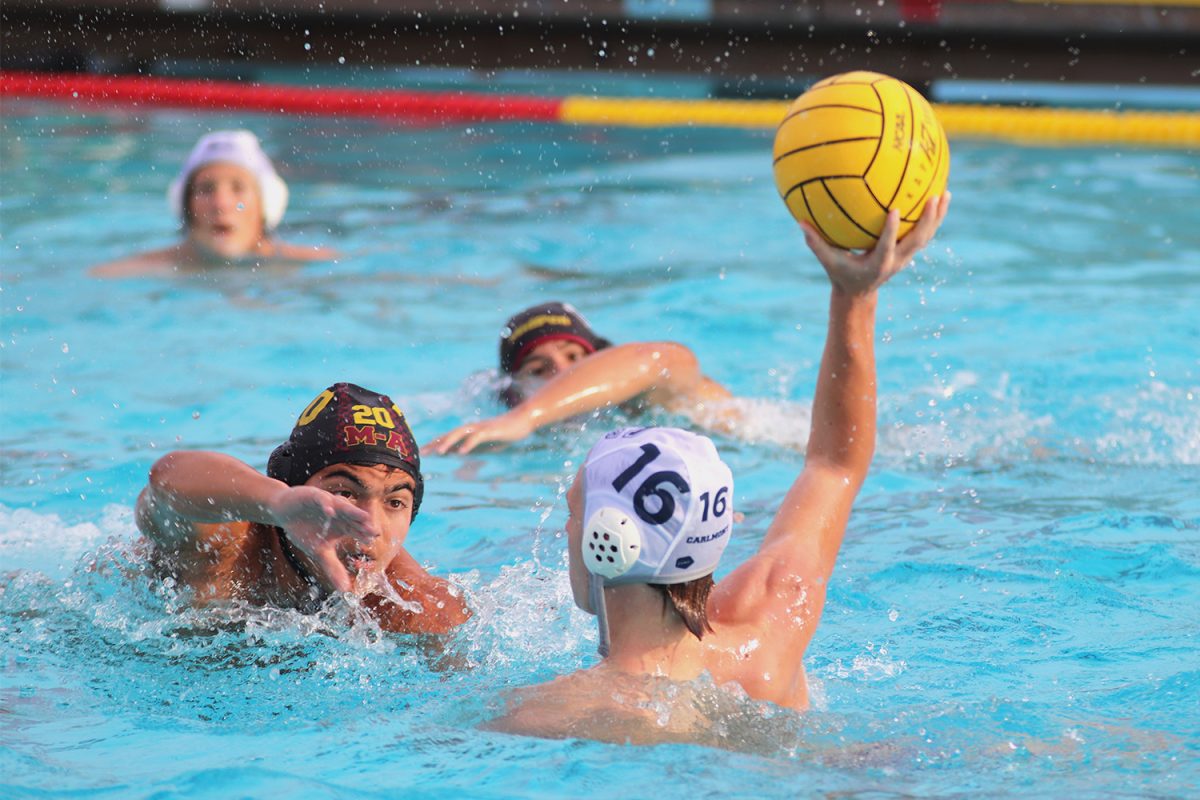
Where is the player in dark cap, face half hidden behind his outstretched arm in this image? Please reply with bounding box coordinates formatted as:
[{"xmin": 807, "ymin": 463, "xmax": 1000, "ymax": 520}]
[{"xmin": 426, "ymin": 302, "xmax": 731, "ymax": 453}]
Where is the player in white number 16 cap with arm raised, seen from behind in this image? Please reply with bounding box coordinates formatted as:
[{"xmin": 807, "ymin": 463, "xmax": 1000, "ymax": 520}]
[{"xmin": 491, "ymin": 194, "xmax": 949, "ymax": 741}]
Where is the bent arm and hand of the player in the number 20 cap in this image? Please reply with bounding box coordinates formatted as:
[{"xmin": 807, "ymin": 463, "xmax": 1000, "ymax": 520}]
[{"xmin": 136, "ymin": 451, "xmax": 378, "ymax": 591}]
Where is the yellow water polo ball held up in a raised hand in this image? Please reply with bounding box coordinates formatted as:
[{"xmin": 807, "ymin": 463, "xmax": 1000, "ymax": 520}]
[{"xmin": 775, "ymin": 72, "xmax": 950, "ymax": 249}]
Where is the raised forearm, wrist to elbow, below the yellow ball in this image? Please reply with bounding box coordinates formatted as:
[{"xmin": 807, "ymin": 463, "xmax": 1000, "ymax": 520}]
[{"xmin": 808, "ymin": 287, "xmax": 877, "ymax": 482}]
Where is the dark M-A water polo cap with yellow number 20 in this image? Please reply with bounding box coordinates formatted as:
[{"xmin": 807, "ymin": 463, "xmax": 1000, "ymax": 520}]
[{"xmin": 266, "ymin": 383, "xmax": 425, "ymax": 517}]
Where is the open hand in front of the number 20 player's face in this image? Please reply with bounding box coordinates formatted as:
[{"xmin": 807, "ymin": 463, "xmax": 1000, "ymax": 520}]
[{"xmin": 270, "ymin": 486, "xmax": 379, "ymax": 591}]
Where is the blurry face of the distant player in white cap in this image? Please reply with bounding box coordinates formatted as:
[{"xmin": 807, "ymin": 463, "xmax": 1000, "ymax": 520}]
[{"xmin": 187, "ymin": 162, "xmax": 264, "ymax": 259}]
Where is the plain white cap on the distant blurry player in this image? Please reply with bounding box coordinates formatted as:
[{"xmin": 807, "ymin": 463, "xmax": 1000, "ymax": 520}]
[{"xmin": 167, "ymin": 131, "xmax": 288, "ymax": 233}]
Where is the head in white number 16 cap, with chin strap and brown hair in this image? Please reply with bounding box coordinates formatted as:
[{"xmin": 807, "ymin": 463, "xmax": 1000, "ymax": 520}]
[{"xmin": 568, "ymin": 428, "xmax": 733, "ymax": 655}]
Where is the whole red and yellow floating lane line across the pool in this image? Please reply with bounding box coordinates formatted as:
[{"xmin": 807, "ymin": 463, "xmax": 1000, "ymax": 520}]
[{"xmin": 0, "ymin": 72, "xmax": 1200, "ymax": 148}]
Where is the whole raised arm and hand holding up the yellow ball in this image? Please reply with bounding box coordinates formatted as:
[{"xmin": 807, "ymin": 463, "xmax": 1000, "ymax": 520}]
[{"xmin": 705, "ymin": 194, "xmax": 949, "ymax": 616}]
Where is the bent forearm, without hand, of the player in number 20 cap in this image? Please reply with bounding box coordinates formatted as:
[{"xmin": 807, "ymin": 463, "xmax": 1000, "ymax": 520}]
[{"xmin": 142, "ymin": 451, "xmax": 287, "ymax": 524}]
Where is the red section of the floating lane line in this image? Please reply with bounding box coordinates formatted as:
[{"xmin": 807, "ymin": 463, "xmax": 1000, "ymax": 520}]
[{"xmin": 0, "ymin": 72, "xmax": 563, "ymax": 122}]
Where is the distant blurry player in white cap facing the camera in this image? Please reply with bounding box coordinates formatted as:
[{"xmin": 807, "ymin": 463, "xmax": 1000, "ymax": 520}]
[{"xmin": 92, "ymin": 131, "xmax": 334, "ymax": 277}]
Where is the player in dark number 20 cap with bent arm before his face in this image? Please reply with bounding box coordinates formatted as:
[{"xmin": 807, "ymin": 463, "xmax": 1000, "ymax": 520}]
[{"xmin": 137, "ymin": 384, "xmax": 469, "ymax": 633}]
